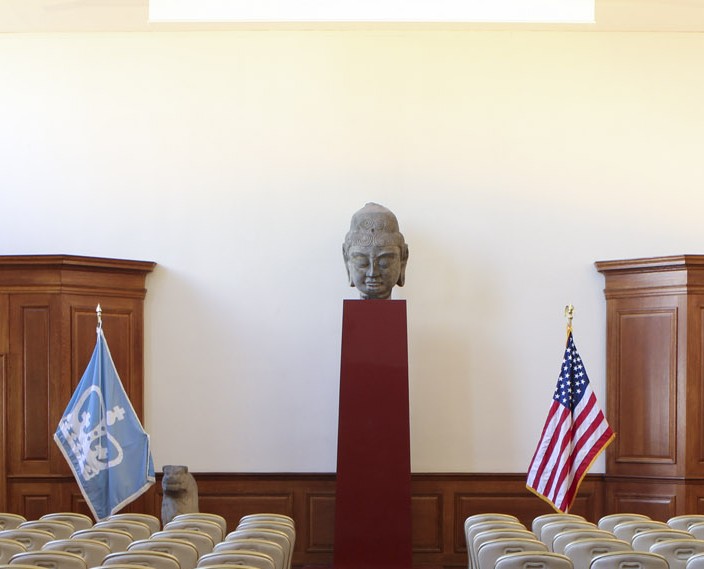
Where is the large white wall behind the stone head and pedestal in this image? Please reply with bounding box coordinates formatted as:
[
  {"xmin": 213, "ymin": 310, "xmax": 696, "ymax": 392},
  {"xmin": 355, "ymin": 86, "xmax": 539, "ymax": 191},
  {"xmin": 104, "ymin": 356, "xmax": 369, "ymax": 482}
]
[{"xmin": 0, "ymin": 30, "xmax": 704, "ymax": 472}]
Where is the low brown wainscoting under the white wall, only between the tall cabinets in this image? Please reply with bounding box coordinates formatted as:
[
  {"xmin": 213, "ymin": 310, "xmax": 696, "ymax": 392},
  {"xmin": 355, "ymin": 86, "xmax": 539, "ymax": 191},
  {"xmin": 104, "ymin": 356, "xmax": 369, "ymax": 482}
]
[{"xmin": 146, "ymin": 473, "xmax": 604, "ymax": 568}]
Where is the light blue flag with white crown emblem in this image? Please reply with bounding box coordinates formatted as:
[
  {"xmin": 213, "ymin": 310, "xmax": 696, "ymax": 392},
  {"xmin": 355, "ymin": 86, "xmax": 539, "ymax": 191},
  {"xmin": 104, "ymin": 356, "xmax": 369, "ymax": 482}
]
[{"xmin": 54, "ymin": 327, "xmax": 155, "ymax": 520}]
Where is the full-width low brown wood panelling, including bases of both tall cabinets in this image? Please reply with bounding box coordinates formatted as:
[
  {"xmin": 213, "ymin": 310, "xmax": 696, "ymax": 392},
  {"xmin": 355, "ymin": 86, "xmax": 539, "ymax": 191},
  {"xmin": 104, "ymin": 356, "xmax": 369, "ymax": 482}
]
[{"xmin": 13, "ymin": 473, "xmax": 704, "ymax": 569}]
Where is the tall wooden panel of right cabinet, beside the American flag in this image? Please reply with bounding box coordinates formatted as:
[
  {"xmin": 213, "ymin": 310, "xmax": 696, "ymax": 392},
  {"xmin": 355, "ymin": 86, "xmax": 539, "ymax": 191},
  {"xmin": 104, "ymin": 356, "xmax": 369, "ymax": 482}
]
[{"xmin": 607, "ymin": 297, "xmax": 683, "ymax": 476}]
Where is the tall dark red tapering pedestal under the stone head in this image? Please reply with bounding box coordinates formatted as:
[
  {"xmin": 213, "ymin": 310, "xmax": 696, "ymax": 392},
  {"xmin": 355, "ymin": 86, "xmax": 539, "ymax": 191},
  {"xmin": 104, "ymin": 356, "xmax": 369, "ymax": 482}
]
[{"xmin": 333, "ymin": 300, "xmax": 412, "ymax": 569}]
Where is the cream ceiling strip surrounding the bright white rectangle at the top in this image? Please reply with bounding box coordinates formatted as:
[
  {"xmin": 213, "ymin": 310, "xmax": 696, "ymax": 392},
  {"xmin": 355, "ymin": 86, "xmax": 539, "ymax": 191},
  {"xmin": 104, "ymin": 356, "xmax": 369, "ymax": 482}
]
[{"xmin": 0, "ymin": 0, "xmax": 704, "ymax": 33}]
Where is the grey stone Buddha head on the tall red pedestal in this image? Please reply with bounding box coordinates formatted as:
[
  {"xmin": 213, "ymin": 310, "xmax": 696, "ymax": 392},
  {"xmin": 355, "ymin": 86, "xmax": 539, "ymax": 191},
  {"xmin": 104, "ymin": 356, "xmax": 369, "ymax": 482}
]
[{"xmin": 342, "ymin": 203, "xmax": 408, "ymax": 300}]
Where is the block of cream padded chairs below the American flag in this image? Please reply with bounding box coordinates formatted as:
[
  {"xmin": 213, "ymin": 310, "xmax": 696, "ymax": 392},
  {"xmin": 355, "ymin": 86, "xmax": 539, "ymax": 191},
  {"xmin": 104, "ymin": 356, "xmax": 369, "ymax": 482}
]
[{"xmin": 464, "ymin": 513, "xmax": 704, "ymax": 569}]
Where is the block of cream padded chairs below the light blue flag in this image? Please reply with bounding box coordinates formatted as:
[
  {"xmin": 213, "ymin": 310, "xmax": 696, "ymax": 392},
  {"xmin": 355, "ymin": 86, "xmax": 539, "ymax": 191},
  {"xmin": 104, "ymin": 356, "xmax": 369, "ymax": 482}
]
[{"xmin": 0, "ymin": 513, "xmax": 295, "ymax": 569}]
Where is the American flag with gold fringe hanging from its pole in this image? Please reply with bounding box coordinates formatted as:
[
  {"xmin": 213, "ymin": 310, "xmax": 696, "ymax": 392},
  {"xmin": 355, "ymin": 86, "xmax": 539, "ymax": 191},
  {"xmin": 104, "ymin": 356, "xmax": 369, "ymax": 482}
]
[{"xmin": 526, "ymin": 330, "xmax": 615, "ymax": 512}]
